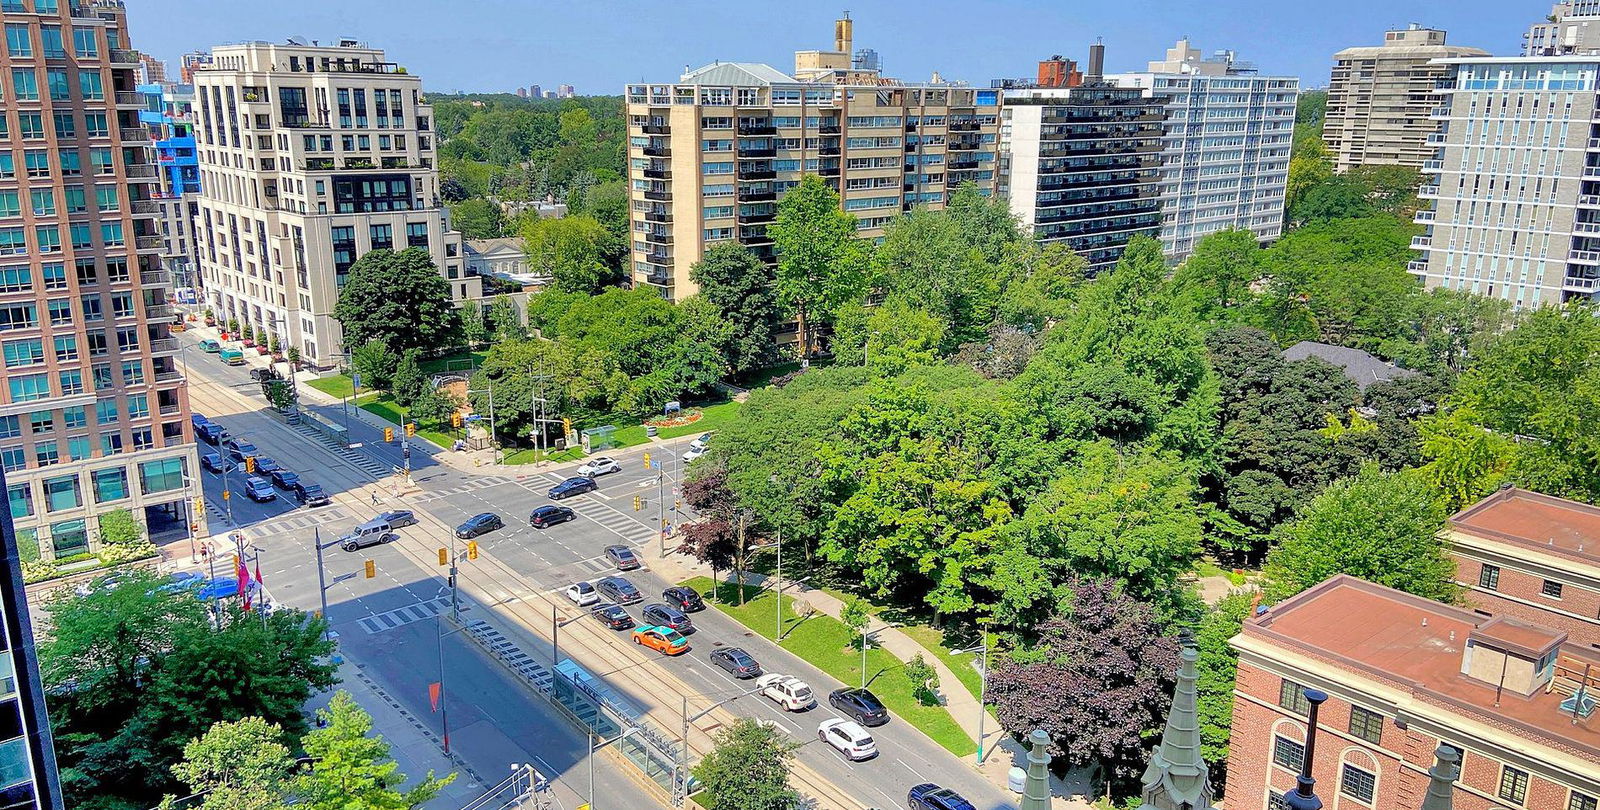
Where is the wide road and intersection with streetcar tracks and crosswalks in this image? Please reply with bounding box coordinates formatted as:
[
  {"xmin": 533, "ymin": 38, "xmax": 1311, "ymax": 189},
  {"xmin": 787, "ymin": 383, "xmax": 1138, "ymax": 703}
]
[{"xmin": 178, "ymin": 329, "xmax": 1013, "ymax": 810}]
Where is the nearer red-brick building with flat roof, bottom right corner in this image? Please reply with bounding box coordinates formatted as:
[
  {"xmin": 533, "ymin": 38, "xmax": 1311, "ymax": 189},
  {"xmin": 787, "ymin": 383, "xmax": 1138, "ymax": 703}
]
[{"xmin": 1226, "ymin": 576, "xmax": 1600, "ymax": 810}]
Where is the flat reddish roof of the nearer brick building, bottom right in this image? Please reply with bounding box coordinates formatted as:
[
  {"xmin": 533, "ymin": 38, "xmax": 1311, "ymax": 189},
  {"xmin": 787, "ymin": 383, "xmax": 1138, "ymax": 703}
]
[{"xmin": 1243, "ymin": 575, "xmax": 1600, "ymax": 760}]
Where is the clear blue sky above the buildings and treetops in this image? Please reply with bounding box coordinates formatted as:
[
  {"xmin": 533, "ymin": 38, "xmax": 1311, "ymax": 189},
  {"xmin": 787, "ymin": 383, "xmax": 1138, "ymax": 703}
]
[{"xmin": 137, "ymin": 0, "xmax": 1550, "ymax": 93}]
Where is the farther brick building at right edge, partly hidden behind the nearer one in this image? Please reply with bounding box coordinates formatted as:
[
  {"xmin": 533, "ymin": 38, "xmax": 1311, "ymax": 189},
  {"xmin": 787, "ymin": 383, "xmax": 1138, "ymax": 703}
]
[{"xmin": 1448, "ymin": 488, "xmax": 1600, "ymax": 645}]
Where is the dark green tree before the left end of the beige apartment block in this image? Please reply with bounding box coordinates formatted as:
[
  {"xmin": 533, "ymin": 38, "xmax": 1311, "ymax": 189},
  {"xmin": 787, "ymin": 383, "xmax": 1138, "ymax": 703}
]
[{"xmin": 690, "ymin": 242, "xmax": 779, "ymax": 373}]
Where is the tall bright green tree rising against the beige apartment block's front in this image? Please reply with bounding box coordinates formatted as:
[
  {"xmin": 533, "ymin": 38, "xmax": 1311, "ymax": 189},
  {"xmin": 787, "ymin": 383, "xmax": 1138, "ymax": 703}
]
[{"xmin": 766, "ymin": 174, "xmax": 867, "ymax": 357}]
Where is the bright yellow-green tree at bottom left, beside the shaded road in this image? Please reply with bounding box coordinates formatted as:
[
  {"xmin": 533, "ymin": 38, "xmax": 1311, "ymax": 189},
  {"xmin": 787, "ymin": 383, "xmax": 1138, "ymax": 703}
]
[{"xmin": 293, "ymin": 692, "xmax": 456, "ymax": 810}]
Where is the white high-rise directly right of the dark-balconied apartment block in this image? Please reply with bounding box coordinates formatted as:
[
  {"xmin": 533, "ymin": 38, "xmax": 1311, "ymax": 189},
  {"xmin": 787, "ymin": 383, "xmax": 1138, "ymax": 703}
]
[{"xmin": 1106, "ymin": 38, "xmax": 1299, "ymax": 261}]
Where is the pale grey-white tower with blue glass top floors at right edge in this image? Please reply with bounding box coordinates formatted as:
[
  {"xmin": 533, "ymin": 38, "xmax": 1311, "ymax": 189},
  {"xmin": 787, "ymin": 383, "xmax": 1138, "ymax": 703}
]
[{"xmin": 1410, "ymin": 56, "xmax": 1600, "ymax": 309}]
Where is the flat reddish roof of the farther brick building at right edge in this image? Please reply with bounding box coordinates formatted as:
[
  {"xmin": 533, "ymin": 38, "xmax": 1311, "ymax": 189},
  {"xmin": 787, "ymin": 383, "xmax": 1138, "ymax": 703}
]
[{"xmin": 1450, "ymin": 487, "xmax": 1600, "ymax": 563}]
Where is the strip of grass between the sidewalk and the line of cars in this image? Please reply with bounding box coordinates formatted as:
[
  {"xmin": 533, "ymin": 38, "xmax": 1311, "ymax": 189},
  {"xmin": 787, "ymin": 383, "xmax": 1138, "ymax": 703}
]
[{"xmin": 683, "ymin": 576, "xmax": 974, "ymax": 756}]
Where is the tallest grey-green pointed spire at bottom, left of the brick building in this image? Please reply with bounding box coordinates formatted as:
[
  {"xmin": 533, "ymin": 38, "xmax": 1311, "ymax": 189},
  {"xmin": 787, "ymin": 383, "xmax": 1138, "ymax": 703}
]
[{"xmin": 1142, "ymin": 639, "xmax": 1213, "ymax": 810}]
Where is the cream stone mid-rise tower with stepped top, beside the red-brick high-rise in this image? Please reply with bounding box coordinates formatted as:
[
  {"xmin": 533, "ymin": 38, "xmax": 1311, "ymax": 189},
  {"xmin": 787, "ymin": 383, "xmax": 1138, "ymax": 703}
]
[{"xmin": 194, "ymin": 40, "xmax": 482, "ymax": 368}]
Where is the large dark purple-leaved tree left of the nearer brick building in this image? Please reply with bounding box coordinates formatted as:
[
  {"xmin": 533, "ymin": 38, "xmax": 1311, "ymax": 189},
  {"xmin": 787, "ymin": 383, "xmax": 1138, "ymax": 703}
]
[{"xmin": 989, "ymin": 578, "xmax": 1178, "ymax": 792}]
